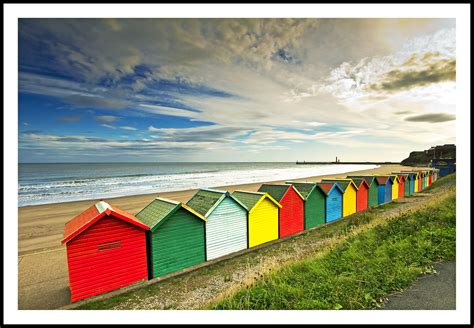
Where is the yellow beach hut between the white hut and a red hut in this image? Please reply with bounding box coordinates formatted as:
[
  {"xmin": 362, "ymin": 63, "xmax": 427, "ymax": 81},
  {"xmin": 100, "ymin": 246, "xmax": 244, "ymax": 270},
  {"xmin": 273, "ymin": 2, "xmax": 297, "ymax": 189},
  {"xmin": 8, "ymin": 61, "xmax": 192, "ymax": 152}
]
[{"xmin": 232, "ymin": 190, "xmax": 282, "ymax": 247}]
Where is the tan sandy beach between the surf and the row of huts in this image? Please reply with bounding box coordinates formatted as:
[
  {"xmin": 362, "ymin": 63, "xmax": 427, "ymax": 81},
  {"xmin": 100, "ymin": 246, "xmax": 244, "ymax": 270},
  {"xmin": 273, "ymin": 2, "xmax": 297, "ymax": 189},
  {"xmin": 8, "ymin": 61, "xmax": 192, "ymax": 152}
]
[{"xmin": 18, "ymin": 165, "xmax": 428, "ymax": 309}]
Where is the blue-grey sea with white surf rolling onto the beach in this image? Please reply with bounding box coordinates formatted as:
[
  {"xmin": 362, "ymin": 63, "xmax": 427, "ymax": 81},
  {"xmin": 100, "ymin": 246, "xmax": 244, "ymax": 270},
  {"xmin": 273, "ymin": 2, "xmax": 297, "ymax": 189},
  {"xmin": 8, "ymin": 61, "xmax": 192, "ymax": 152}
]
[{"xmin": 18, "ymin": 162, "xmax": 378, "ymax": 207}]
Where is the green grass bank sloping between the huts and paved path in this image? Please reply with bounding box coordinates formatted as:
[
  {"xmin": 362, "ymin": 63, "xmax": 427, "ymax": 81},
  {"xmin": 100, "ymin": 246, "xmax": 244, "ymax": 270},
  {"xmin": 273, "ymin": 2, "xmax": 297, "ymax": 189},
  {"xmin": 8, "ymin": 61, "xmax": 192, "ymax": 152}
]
[{"xmin": 211, "ymin": 190, "xmax": 456, "ymax": 309}]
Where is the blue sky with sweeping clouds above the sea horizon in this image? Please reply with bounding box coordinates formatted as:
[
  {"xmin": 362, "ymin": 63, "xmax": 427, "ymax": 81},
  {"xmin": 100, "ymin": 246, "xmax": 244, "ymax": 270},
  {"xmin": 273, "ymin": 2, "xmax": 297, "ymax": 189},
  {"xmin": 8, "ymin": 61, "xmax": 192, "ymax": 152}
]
[{"xmin": 18, "ymin": 18, "xmax": 456, "ymax": 163}]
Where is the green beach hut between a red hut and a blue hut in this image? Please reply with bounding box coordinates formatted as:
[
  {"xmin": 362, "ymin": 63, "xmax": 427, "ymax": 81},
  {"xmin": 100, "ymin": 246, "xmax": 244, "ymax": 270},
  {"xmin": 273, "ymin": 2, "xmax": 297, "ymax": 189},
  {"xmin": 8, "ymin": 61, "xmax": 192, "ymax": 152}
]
[{"xmin": 286, "ymin": 181, "xmax": 326, "ymax": 230}]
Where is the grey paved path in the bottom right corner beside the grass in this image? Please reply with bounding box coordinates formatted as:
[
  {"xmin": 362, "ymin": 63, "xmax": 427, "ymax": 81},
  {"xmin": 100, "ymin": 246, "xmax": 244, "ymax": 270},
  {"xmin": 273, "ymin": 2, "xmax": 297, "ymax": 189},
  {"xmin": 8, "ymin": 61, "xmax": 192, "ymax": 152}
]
[{"xmin": 383, "ymin": 261, "xmax": 456, "ymax": 310}]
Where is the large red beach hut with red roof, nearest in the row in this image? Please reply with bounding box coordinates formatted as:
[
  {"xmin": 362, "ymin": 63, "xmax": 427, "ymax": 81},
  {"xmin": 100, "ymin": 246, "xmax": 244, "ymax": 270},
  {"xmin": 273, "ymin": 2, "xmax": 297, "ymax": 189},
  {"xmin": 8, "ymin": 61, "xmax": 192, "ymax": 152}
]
[{"xmin": 62, "ymin": 201, "xmax": 148, "ymax": 302}]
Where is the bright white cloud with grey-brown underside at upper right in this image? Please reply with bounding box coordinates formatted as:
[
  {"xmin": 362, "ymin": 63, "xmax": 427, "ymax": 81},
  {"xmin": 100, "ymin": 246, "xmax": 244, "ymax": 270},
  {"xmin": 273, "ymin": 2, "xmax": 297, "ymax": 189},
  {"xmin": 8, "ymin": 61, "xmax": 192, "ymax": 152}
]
[{"xmin": 318, "ymin": 29, "xmax": 456, "ymax": 105}]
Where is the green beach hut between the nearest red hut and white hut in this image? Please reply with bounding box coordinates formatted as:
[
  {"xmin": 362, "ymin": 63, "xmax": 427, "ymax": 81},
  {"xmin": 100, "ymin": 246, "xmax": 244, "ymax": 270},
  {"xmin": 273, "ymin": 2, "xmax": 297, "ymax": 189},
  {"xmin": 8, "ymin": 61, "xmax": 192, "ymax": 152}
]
[{"xmin": 136, "ymin": 197, "xmax": 206, "ymax": 279}]
